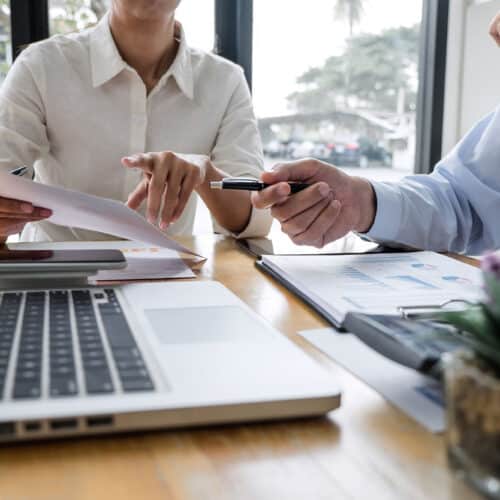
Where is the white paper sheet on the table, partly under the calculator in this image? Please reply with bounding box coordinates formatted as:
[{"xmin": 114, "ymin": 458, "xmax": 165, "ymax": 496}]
[{"xmin": 300, "ymin": 328, "xmax": 446, "ymax": 433}]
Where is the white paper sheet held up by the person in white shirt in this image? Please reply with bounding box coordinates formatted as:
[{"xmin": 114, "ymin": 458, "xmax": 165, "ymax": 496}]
[{"xmin": 0, "ymin": 171, "xmax": 203, "ymax": 255}]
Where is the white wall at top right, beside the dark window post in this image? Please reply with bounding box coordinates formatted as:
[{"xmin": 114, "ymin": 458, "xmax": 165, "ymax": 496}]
[{"xmin": 443, "ymin": 0, "xmax": 500, "ymax": 154}]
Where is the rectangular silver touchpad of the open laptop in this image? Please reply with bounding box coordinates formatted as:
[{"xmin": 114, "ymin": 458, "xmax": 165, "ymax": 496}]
[{"xmin": 144, "ymin": 306, "xmax": 269, "ymax": 344}]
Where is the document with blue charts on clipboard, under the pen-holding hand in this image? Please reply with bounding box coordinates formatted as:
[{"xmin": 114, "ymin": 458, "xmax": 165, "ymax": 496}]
[{"xmin": 258, "ymin": 252, "xmax": 482, "ymax": 326}]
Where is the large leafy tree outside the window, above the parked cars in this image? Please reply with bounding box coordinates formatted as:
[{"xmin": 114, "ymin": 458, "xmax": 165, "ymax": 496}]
[{"xmin": 288, "ymin": 25, "xmax": 420, "ymax": 112}]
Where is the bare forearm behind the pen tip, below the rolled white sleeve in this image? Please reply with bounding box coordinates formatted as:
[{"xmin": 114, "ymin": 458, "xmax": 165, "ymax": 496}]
[{"xmin": 197, "ymin": 161, "xmax": 252, "ymax": 233}]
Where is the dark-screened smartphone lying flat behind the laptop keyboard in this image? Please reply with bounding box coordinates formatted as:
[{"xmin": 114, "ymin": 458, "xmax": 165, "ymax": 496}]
[{"xmin": 0, "ymin": 249, "xmax": 127, "ymax": 275}]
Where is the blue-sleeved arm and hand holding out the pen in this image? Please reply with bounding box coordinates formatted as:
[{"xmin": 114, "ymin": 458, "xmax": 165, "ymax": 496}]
[{"xmin": 253, "ymin": 111, "xmax": 500, "ymax": 254}]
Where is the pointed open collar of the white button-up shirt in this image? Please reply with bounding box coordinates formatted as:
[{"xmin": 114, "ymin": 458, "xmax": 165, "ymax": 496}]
[{"xmin": 90, "ymin": 14, "xmax": 194, "ymax": 99}]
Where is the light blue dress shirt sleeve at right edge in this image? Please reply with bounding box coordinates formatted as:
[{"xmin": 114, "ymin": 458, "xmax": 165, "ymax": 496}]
[{"xmin": 367, "ymin": 108, "xmax": 500, "ymax": 255}]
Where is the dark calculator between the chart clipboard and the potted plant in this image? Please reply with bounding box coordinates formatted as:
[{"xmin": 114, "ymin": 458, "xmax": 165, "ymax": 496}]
[{"xmin": 343, "ymin": 313, "xmax": 466, "ymax": 378}]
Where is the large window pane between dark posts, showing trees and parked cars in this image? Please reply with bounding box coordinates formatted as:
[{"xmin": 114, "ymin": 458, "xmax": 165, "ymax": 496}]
[{"xmin": 253, "ymin": 0, "xmax": 422, "ymax": 178}]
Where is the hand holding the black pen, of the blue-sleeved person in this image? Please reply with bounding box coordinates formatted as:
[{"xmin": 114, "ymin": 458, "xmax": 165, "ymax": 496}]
[{"xmin": 252, "ymin": 160, "xmax": 375, "ymax": 248}]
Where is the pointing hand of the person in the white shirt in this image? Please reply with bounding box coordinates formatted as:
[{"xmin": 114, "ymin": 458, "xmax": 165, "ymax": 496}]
[{"xmin": 122, "ymin": 151, "xmax": 207, "ymax": 229}]
